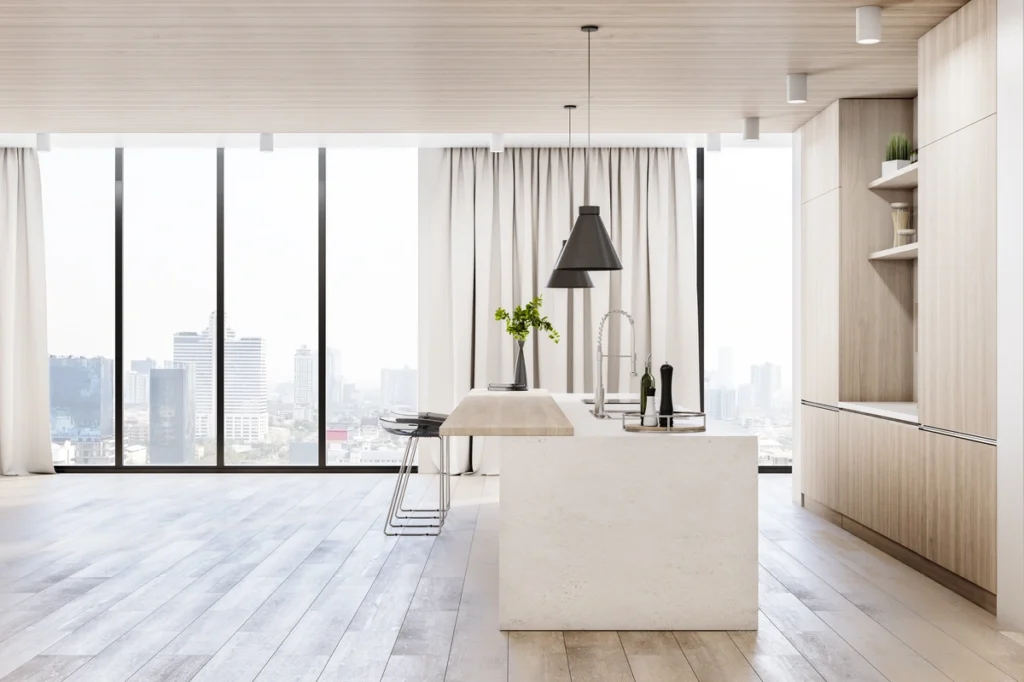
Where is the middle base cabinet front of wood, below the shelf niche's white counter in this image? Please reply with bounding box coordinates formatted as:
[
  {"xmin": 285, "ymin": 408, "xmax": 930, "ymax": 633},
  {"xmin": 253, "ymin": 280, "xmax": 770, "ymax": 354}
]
[{"xmin": 839, "ymin": 412, "xmax": 927, "ymax": 555}]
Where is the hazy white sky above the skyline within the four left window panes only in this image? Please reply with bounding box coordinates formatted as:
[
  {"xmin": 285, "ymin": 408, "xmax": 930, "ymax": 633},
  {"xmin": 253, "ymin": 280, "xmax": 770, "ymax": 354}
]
[{"xmin": 41, "ymin": 148, "xmax": 418, "ymax": 384}]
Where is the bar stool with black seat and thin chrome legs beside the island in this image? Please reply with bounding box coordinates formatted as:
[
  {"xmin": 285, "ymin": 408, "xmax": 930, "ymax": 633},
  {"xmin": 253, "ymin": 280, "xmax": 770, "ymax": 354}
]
[{"xmin": 380, "ymin": 412, "xmax": 452, "ymax": 536}]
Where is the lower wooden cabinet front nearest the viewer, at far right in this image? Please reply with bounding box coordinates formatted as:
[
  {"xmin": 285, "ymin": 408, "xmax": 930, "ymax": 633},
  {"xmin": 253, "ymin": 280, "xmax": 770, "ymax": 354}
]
[{"xmin": 921, "ymin": 431, "xmax": 996, "ymax": 593}]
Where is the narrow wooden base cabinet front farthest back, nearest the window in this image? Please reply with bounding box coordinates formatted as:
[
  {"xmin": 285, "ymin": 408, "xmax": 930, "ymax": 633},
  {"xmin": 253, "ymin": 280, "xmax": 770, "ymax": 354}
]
[{"xmin": 800, "ymin": 404, "xmax": 843, "ymax": 512}]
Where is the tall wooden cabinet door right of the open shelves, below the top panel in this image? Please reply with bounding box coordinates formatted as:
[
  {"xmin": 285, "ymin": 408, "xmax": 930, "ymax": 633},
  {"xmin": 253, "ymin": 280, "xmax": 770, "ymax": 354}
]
[{"xmin": 918, "ymin": 116, "xmax": 996, "ymax": 439}]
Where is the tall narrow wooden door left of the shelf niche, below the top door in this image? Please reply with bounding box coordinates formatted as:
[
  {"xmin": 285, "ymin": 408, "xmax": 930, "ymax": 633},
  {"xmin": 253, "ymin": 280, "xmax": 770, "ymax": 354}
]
[{"xmin": 801, "ymin": 189, "xmax": 840, "ymax": 406}]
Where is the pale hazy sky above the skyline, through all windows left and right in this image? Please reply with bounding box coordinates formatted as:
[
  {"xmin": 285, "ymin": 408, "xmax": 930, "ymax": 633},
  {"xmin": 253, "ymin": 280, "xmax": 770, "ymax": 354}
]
[{"xmin": 40, "ymin": 147, "xmax": 793, "ymax": 385}]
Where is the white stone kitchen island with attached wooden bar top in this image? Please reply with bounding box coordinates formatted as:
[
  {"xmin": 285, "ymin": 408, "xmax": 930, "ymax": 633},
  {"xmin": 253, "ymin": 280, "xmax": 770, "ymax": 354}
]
[{"xmin": 441, "ymin": 390, "xmax": 758, "ymax": 630}]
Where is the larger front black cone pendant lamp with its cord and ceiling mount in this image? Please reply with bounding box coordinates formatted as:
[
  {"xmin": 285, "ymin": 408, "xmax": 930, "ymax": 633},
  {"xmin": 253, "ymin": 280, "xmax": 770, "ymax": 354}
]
[{"xmin": 555, "ymin": 26, "xmax": 623, "ymax": 270}]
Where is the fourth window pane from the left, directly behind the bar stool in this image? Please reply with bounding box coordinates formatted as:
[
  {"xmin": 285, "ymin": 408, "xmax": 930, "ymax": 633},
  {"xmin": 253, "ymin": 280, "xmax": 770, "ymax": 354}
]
[{"xmin": 326, "ymin": 148, "xmax": 419, "ymax": 466}]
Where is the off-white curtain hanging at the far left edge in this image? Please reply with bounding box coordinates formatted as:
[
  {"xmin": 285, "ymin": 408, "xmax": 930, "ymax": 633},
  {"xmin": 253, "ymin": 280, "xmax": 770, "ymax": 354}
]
[{"xmin": 0, "ymin": 148, "xmax": 53, "ymax": 475}]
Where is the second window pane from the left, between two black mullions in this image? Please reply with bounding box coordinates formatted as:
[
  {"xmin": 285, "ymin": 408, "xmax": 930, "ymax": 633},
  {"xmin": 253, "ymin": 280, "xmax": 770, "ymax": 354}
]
[{"xmin": 122, "ymin": 148, "xmax": 217, "ymax": 466}]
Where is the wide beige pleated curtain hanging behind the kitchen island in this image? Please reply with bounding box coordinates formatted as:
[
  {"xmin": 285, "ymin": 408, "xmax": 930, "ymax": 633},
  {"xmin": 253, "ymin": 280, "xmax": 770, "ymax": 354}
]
[{"xmin": 419, "ymin": 148, "xmax": 699, "ymax": 470}]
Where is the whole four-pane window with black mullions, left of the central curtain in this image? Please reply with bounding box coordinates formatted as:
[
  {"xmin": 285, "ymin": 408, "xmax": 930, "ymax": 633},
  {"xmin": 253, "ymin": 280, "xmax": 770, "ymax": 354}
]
[{"xmin": 40, "ymin": 140, "xmax": 418, "ymax": 469}]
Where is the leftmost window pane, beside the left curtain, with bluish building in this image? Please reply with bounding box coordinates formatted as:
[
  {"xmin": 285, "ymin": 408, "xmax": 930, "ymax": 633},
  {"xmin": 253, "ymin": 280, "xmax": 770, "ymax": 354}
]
[{"xmin": 40, "ymin": 150, "xmax": 115, "ymax": 466}]
